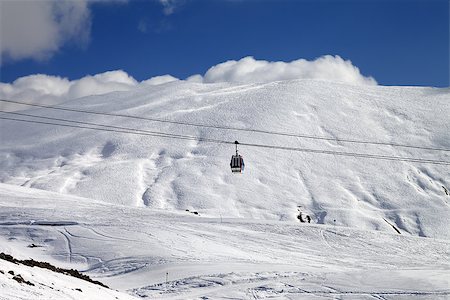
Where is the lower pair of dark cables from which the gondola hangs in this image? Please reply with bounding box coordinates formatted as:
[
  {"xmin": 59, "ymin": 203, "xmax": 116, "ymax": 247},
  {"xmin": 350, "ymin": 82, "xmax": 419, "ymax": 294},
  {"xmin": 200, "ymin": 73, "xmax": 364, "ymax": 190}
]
[{"xmin": 0, "ymin": 116, "xmax": 450, "ymax": 166}]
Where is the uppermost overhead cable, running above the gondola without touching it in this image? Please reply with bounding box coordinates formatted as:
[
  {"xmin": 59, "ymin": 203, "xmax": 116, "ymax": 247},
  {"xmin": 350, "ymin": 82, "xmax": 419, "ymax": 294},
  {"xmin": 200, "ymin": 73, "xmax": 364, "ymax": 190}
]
[{"xmin": 0, "ymin": 99, "xmax": 450, "ymax": 151}]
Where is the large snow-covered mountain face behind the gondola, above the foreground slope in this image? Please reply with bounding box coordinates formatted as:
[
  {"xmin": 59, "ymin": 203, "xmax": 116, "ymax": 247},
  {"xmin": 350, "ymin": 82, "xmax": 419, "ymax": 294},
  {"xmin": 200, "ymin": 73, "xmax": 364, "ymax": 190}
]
[{"xmin": 0, "ymin": 80, "xmax": 450, "ymax": 239}]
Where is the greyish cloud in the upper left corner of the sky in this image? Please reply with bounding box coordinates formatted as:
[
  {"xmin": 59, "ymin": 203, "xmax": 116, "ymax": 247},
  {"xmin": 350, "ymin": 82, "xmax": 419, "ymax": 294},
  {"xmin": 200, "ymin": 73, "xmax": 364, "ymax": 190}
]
[{"xmin": 0, "ymin": 0, "xmax": 91, "ymax": 60}]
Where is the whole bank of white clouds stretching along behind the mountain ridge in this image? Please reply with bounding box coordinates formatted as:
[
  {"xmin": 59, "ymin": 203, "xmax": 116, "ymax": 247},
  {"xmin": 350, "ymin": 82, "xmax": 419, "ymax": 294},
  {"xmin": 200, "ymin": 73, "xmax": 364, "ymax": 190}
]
[{"xmin": 0, "ymin": 55, "xmax": 376, "ymax": 109}]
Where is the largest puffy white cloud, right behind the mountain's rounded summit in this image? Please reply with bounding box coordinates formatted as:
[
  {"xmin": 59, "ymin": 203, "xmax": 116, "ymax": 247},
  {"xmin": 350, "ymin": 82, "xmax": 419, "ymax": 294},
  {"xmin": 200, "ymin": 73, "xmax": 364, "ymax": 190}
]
[{"xmin": 203, "ymin": 55, "xmax": 377, "ymax": 85}]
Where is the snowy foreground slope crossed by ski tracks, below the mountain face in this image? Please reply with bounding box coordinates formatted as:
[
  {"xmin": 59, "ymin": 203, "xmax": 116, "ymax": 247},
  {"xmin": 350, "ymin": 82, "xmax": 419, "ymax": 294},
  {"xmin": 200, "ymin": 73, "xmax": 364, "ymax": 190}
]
[{"xmin": 0, "ymin": 184, "xmax": 450, "ymax": 299}]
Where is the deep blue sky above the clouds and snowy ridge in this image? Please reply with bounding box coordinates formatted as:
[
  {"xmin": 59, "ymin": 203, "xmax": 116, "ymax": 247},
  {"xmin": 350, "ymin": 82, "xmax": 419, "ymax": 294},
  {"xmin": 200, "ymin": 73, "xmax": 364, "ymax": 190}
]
[{"xmin": 0, "ymin": 0, "xmax": 449, "ymax": 87}]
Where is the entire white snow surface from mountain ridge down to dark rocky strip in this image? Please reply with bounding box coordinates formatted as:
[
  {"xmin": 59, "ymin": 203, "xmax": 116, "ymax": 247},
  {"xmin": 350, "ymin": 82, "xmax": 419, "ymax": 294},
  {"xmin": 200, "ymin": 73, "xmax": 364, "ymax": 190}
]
[{"xmin": 0, "ymin": 80, "xmax": 450, "ymax": 299}]
